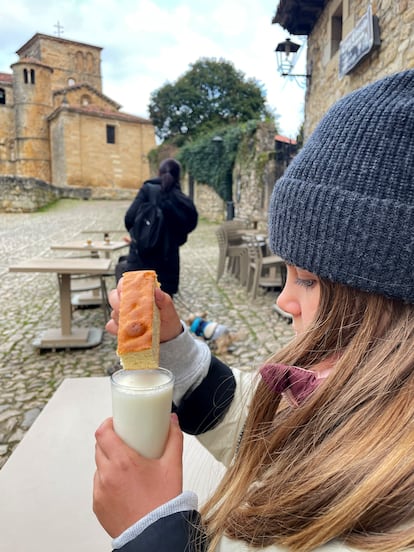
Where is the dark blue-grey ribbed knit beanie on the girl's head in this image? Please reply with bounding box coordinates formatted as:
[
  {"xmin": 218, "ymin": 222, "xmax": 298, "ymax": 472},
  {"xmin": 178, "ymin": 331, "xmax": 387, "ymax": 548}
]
[{"xmin": 269, "ymin": 70, "xmax": 414, "ymax": 303}]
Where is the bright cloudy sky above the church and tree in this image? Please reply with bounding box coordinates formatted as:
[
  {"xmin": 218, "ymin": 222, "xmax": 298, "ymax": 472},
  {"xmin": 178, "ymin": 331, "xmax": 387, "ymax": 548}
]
[{"xmin": 0, "ymin": 0, "xmax": 305, "ymax": 138}]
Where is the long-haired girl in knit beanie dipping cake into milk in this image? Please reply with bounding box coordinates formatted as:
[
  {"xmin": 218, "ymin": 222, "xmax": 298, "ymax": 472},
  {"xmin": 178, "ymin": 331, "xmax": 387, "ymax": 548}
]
[{"xmin": 94, "ymin": 71, "xmax": 414, "ymax": 552}]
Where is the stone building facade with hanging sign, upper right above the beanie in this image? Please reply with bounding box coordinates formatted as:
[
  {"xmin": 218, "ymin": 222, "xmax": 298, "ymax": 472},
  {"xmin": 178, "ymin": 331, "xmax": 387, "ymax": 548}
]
[{"xmin": 273, "ymin": 0, "xmax": 414, "ymax": 138}]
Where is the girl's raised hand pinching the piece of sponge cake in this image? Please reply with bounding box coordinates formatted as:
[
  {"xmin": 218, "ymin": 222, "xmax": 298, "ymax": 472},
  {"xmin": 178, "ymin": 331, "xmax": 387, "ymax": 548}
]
[{"xmin": 105, "ymin": 278, "xmax": 182, "ymax": 342}]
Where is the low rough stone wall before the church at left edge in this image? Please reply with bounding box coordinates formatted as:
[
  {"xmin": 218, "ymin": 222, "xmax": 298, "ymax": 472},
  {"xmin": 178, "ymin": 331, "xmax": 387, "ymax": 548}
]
[{"xmin": 0, "ymin": 176, "xmax": 91, "ymax": 213}]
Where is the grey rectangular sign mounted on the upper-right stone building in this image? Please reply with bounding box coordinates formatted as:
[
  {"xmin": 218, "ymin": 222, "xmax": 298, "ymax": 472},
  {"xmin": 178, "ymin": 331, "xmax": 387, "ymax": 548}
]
[{"xmin": 339, "ymin": 5, "xmax": 379, "ymax": 79}]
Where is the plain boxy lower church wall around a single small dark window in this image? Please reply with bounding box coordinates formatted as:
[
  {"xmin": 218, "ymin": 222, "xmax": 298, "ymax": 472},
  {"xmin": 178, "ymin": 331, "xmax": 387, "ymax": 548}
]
[{"xmin": 50, "ymin": 106, "xmax": 155, "ymax": 190}]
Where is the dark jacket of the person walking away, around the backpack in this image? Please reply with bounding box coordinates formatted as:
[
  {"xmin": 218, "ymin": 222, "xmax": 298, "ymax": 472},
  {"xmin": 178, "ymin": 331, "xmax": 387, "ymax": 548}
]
[{"xmin": 125, "ymin": 178, "xmax": 198, "ymax": 295}]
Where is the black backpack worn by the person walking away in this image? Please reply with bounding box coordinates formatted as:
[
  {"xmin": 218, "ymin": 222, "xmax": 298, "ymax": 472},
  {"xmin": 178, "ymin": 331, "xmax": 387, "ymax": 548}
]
[{"xmin": 130, "ymin": 184, "xmax": 167, "ymax": 255}]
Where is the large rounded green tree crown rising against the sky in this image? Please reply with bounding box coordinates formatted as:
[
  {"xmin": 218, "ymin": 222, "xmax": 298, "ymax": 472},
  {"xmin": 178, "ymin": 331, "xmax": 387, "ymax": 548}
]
[{"xmin": 149, "ymin": 58, "xmax": 269, "ymax": 145}]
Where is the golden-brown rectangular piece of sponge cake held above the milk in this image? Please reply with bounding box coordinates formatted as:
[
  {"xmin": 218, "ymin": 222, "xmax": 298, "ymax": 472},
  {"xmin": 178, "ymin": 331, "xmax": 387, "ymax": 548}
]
[{"xmin": 117, "ymin": 270, "xmax": 160, "ymax": 370}]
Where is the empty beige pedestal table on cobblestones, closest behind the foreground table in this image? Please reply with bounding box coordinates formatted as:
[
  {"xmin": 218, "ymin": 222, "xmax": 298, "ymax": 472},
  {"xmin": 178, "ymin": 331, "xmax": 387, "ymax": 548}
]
[{"xmin": 9, "ymin": 257, "xmax": 111, "ymax": 349}]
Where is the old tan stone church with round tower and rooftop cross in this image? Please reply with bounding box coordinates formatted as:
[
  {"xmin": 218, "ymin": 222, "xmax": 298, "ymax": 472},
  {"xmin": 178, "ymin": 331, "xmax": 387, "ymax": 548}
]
[{"xmin": 0, "ymin": 33, "xmax": 156, "ymax": 193}]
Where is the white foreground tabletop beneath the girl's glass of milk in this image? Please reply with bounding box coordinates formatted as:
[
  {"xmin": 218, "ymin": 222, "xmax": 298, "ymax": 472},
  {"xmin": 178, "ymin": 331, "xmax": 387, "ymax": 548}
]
[{"xmin": 0, "ymin": 377, "xmax": 223, "ymax": 552}]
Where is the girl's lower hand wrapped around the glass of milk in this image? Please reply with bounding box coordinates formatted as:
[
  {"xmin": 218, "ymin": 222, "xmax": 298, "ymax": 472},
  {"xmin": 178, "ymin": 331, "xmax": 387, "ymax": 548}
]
[{"xmin": 93, "ymin": 414, "xmax": 183, "ymax": 538}]
